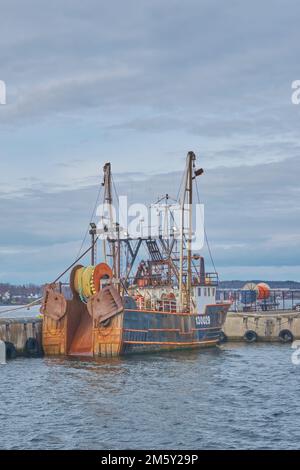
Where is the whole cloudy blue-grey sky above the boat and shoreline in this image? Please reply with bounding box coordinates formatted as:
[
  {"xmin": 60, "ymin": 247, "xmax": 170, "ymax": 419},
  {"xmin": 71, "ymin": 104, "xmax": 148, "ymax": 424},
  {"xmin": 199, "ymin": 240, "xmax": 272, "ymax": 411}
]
[{"xmin": 0, "ymin": 0, "xmax": 300, "ymax": 283}]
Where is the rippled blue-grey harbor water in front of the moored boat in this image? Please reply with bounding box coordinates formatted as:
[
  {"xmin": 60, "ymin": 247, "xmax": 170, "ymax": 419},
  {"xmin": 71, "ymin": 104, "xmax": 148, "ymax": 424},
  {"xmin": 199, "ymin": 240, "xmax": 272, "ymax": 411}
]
[{"xmin": 0, "ymin": 343, "xmax": 300, "ymax": 450}]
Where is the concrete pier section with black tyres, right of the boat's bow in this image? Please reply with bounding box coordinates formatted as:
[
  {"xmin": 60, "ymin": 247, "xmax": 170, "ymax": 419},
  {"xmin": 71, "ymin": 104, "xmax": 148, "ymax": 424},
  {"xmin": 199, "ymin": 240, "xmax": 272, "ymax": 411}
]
[{"xmin": 223, "ymin": 310, "xmax": 300, "ymax": 342}]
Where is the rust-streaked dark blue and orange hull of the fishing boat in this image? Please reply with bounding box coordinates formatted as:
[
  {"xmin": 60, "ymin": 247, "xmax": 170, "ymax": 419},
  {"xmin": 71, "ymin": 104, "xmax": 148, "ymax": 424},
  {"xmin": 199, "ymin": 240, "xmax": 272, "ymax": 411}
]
[{"xmin": 43, "ymin": 304, "xmax": 228, "ymax": 357}]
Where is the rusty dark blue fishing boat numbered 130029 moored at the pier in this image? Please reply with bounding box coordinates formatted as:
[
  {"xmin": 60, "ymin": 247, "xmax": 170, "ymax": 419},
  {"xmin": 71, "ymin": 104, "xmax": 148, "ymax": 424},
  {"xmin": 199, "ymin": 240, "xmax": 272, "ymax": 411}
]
[{"xmin": 41, "ymin": 152, "xmax": 230, "ymax": 358}]
